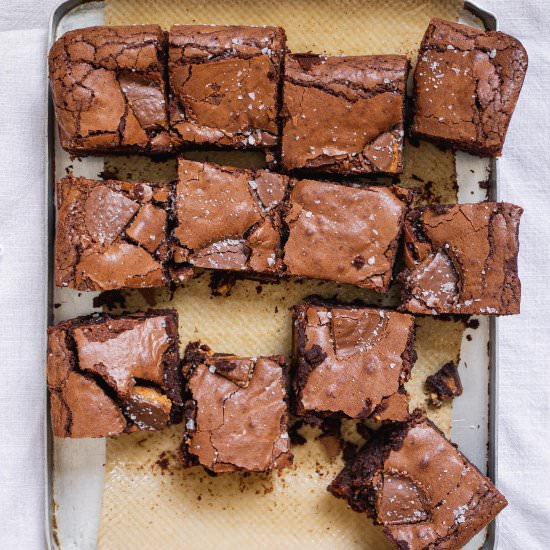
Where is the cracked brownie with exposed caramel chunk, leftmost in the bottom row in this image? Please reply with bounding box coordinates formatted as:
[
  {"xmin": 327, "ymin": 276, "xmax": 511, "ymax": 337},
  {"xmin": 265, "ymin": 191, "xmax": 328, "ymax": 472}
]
[{"xmin": 48, "ymin": 310, "xmax": 183, "ymax": 438}]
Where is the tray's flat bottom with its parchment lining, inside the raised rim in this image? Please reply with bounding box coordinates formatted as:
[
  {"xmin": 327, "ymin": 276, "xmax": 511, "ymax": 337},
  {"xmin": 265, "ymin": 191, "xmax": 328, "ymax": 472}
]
[{"xmin": 49, "ymin": 0, "xmax": 496, "ymax": 550}]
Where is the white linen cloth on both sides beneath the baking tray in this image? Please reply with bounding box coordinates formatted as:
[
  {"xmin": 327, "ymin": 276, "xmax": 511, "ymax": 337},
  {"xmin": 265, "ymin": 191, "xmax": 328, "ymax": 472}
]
[{"xmin": 0, "ymin": 0, "xmax": 550, "ymax": 550}]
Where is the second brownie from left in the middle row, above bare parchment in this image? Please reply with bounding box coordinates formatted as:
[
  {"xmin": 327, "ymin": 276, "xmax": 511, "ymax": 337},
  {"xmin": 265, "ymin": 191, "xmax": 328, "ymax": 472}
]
[{"xmin": 173, "ymin": 158, "xmax": 289, "ymax": 276}]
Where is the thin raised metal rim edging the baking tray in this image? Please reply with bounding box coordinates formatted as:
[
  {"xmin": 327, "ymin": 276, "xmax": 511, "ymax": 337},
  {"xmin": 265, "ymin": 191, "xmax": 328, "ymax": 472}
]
[{"xmin": 43, "ymin": 0, "xmax": 500, "ymax": 550}]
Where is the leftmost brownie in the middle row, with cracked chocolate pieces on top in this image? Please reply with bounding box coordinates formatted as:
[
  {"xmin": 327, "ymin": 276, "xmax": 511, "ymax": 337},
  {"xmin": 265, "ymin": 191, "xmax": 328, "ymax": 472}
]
[{"xmin": 55, "ymin": 175, "xmax": 176, "ymax": 290}]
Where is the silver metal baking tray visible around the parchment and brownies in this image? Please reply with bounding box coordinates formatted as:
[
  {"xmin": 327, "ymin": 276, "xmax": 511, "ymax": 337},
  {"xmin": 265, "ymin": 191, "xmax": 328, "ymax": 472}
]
[{"xmin": 43, "ymin": 0, "xmax": 499, "ymax": 550}]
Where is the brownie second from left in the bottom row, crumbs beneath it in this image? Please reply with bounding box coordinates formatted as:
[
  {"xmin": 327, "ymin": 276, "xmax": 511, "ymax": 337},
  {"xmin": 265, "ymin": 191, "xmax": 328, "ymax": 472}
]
[{"xmin": 182, "ymin": 342, "xmax": 292, "ymax": 473}]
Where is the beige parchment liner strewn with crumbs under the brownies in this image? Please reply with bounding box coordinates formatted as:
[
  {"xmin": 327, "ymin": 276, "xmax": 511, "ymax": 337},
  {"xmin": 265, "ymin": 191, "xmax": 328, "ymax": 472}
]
[{"xmin": 98, "ymin": 0, "xmax": 464, "ymax": 550}]
